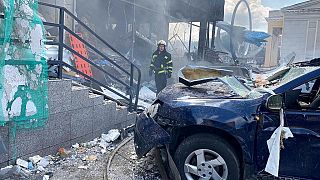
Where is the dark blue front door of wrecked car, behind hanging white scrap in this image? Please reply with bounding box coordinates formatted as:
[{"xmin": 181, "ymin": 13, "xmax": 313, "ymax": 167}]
[{"xmin": 257, "ymin": 91, "xmax": 320, "ymax": 179}]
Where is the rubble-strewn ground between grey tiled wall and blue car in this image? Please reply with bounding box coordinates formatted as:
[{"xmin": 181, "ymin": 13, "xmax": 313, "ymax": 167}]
[{"xmin": 0, "ymin": 129, "xmax": 159, "ymax": 180}]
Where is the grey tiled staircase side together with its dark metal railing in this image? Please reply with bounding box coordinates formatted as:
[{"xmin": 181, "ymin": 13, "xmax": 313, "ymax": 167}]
[{"xmin": 0, "ymin": 2, "xmax": 141, "ymax": 167}]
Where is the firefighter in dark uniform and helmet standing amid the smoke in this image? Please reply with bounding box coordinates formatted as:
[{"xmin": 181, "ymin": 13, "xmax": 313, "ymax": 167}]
[{"xmin": 149, "ymin": 40, "xmax": 172, "ymax": 94}]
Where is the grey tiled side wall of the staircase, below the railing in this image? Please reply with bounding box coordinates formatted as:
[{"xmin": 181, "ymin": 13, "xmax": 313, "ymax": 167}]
[{"xmin": 0, "ymin": 80, "xmax": 136, "ymax": 167}]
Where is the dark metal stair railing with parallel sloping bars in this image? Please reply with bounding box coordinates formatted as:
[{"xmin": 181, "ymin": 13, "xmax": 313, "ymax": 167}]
[{"xmin": 39, "ymin": 2, "xmax": 141, "ymax": 111}]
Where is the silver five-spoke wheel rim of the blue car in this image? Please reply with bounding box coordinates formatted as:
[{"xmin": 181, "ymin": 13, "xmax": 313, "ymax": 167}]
[{"xmin": 184, "ymin": 149, "xmax": 228, "ymax": 180}]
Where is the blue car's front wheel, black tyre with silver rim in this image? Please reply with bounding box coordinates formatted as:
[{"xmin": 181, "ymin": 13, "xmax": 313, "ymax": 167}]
[{"xmin": 174, "ymin": 134, "xmax": 240, "ymax": 180}]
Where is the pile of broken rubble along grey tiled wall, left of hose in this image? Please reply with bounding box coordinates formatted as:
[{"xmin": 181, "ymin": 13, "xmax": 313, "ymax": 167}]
[{"xmin": 0, "ymin": 129, "xmax": 120, "ymax": 180}]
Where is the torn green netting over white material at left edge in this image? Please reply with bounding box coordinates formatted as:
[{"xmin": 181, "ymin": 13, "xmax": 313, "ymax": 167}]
[{"xmin": 0, "ymin": 0, "xmax": 48, "ymax": 128}]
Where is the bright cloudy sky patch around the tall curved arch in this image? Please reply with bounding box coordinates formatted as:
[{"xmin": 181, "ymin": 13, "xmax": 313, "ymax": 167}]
[{"xmin": 225, "ymin": 0, "xmax": 271, "ymax": 31}]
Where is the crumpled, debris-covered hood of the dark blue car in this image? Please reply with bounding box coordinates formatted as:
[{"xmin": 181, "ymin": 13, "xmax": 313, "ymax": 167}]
[{"xmin": 158, "ymin": 83, "xmax": 265, "ymax": 118}]
